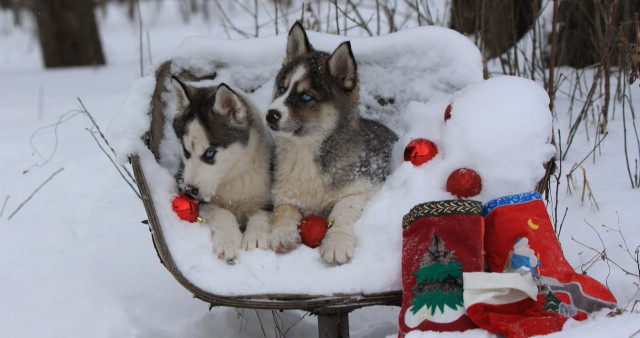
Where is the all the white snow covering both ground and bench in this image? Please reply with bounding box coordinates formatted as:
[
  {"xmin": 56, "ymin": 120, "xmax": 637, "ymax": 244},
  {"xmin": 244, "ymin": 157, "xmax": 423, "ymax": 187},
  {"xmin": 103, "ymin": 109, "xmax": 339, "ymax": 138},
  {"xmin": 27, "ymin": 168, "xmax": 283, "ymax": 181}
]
[{"xmin": 0, "ymin": 2, "xmax": 640, "ymax": 337}]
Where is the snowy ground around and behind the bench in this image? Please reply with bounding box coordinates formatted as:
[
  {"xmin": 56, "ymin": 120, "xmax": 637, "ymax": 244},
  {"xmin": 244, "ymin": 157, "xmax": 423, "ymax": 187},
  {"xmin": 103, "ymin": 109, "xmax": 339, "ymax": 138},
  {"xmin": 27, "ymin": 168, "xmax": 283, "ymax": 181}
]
[{"xmin": 0, "ymin": 3, "xmax": 640, "ymax": 337}]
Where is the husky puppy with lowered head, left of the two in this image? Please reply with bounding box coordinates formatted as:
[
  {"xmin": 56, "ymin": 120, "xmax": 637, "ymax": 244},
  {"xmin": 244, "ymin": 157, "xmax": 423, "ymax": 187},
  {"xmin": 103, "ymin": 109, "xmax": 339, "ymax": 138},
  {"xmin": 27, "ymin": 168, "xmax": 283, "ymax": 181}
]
[{"xmin": 172, "ymin": 78, "xmax": 273, "ymax": 262}]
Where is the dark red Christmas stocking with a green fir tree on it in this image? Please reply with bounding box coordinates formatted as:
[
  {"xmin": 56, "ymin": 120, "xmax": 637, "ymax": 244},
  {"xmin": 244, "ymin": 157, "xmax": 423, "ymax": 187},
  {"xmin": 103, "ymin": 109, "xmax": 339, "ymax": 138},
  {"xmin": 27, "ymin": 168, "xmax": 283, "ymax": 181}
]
[{"xmin": 399, "ymin": 200, "xmax": 484, "ymax": 337}]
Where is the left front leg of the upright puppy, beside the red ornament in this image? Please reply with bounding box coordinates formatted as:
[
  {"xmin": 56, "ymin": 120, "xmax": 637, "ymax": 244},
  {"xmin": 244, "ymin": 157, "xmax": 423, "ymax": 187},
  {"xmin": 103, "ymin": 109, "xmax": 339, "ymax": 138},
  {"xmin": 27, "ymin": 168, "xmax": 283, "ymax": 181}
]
[{"xmin": 269, "ymin": 204, "xmax": 302, "ymax": 253}]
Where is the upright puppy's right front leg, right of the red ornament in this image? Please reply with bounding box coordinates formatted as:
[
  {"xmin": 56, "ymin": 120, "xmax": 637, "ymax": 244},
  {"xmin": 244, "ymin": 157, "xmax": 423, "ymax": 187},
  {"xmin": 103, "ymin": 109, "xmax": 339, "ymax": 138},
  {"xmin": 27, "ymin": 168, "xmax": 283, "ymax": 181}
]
[{"xmin": 320, "ymin": 194, "xmax": 370, "ymax": 265}]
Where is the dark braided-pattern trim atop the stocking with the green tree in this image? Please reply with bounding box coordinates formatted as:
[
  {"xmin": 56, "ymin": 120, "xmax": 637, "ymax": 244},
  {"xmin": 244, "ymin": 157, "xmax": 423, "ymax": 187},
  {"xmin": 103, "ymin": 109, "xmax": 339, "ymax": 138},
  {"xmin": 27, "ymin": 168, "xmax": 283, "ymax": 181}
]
[{"xmin": 402, "ymin": 200, "xmax": 482, "ymax": 229}]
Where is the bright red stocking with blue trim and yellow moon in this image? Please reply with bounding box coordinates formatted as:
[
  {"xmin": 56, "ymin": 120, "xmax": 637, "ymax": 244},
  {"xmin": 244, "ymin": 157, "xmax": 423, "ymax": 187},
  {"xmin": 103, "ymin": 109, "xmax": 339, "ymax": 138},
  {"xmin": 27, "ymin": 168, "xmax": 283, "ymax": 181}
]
[{"xmin": 483, "ymin": 192, "xmax": 616, "ymax": 320}]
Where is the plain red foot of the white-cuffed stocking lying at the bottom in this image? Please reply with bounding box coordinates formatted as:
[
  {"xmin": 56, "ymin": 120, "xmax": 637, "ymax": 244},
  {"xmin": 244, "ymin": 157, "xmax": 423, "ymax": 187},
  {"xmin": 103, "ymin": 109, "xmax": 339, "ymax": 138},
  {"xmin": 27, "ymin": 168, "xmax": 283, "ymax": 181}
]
[{"xmin": 467, "ymin": 298, "xmax": 568, "ymax": 338}]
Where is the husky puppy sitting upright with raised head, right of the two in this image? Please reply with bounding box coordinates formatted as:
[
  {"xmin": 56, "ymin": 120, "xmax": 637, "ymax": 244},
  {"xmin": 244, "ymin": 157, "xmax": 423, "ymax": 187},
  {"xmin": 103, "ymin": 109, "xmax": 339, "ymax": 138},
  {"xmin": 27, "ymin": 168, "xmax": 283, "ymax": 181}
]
[{"xmin": 266, "ymin": 23, "xmax": 397, "ymax": 264}]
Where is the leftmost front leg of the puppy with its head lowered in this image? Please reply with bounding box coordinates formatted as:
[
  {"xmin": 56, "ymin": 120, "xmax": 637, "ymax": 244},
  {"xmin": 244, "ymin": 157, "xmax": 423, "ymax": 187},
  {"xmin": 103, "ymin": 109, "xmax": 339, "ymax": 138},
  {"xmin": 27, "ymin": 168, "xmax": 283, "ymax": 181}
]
[{"xmin": 200, "ymin": 204, "xmax": 242, "ymax": 264}]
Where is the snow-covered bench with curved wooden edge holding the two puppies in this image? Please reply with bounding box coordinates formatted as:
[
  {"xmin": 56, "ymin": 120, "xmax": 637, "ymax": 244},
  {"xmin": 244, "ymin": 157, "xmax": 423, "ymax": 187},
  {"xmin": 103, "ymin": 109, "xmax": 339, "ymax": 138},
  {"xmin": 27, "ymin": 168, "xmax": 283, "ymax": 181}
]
[{"xmin": 111, "ymin": 27, "xmax": 482, "ymax": 336}]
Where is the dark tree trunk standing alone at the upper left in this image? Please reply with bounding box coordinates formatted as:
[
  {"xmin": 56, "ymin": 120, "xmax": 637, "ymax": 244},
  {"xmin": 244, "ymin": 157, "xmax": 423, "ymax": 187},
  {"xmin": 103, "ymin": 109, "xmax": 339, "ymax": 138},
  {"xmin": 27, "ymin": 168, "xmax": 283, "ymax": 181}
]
[{"xmin": 32, "ymin": 0, "xmax": 105, "ymax": 68}]
